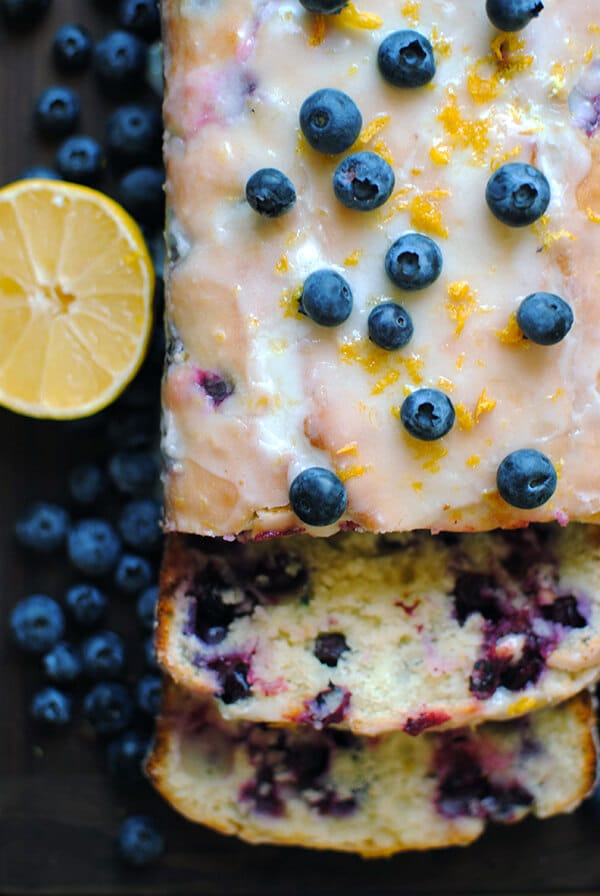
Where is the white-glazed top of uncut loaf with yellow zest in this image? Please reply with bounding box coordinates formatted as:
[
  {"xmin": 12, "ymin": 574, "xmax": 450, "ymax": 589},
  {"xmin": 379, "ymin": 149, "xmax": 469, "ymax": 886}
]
[{"xmin": 163, "ymin": 0, "xmax": 600, "ymax": 536}]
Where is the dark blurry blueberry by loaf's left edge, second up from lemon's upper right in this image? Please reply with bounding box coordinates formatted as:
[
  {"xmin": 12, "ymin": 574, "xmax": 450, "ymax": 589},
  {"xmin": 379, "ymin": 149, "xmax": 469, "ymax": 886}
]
[{"xmin": 105, "ymin": 104, "xmax": 162, "ymax": 171}]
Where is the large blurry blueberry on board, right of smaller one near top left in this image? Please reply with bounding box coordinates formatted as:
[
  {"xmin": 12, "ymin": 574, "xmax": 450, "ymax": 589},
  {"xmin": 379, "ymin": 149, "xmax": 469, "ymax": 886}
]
[{"xmin": 94, "ymin": 31, "xmax": 147, "ymax": 98}]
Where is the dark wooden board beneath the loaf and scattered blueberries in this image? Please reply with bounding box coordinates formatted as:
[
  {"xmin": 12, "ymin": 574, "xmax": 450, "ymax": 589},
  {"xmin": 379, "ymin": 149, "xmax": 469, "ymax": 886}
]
[{"xmin": 0, "ymin": 0, "xmax": 600, "ymax": 896}]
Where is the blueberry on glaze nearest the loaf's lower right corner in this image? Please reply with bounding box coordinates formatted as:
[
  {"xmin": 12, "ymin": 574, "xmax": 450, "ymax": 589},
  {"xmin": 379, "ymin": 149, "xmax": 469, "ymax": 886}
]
[{"xmin": 496, "ymin": 448, "xmax": 557, "ymax": 510}]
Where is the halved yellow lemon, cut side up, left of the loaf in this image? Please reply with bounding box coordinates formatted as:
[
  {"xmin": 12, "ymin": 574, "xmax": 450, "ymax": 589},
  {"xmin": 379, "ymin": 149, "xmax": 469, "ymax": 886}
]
[{"xmin": 0, "ymin": 180, "xmax": 154, "ymax": 419}]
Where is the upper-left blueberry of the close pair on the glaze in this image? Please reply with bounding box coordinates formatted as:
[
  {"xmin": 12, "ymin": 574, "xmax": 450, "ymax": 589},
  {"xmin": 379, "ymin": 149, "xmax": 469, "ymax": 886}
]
[{"xmin": 300, "ymin": 87, "xmax": 362, "ymax": 155}]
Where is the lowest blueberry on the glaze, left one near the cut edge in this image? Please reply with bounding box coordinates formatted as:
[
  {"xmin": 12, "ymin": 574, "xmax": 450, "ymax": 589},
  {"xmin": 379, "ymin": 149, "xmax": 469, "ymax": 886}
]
[{"xmin": 290, "ymin": 467, "xmax": 348, "ymax": 526}]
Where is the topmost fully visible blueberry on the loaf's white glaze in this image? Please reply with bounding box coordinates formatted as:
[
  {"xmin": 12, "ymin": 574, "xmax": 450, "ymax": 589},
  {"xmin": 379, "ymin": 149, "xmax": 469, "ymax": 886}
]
[{"xmin": 377, "ymin": 30, "xmax": 435, "ymax": 87}]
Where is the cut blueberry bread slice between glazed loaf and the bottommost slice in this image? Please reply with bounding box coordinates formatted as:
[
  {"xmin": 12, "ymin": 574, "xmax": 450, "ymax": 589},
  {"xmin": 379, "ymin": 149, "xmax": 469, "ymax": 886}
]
[{"xmin": 156, "ymin": 524, "xmax": 600, "ymax": 735}]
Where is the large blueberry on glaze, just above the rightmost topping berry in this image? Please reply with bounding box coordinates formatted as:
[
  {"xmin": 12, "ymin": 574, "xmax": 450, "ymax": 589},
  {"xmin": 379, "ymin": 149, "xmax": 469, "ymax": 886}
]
[{"xmin": 485, "ymin": 162, "xmax": 550, "ymax": 227}]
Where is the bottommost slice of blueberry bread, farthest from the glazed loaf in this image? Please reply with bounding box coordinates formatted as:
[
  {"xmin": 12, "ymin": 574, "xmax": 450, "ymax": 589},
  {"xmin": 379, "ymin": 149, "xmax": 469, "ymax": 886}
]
[{"xmin": 146, "ymin": 683, "xmax": 596, "ymax": 857}]
